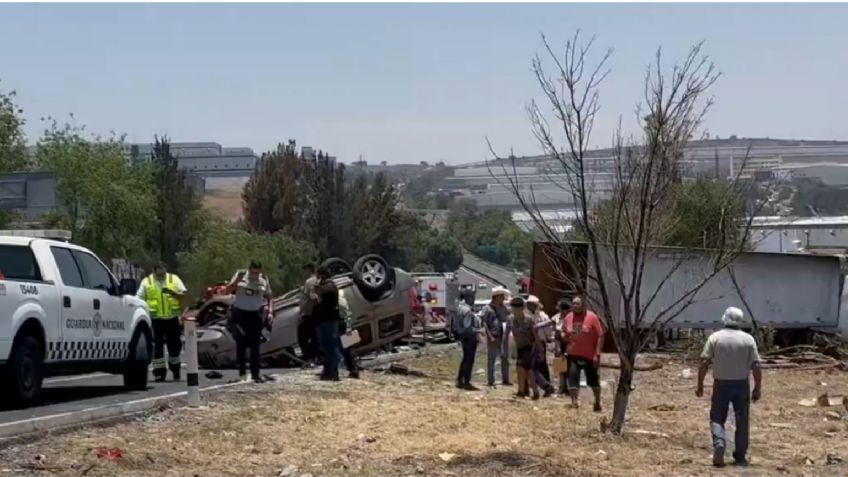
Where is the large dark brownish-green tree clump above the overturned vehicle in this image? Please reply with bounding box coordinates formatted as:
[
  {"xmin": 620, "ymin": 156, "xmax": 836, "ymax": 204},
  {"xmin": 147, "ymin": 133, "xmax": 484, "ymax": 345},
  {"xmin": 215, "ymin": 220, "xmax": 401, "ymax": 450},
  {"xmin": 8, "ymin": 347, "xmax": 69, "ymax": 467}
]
[{"xmin": 242, "ymin": 141, "xmax": 426, "ymax": 268}]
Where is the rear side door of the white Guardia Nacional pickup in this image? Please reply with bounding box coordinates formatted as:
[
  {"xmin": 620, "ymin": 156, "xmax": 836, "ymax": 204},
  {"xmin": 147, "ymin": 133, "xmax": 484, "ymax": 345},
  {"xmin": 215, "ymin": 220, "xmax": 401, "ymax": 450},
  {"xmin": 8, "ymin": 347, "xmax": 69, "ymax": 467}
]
[{"xmin": 49, "ymin": 246, "xmax": 98, "ymax": 361}]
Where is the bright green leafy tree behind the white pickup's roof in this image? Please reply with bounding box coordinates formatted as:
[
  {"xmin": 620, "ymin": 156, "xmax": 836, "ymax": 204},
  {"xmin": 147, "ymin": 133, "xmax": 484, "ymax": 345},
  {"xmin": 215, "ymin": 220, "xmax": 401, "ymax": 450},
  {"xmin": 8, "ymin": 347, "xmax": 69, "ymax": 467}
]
[{"xmin": 37, "ymin": 120, "xmax": 156, "ymax": 260}]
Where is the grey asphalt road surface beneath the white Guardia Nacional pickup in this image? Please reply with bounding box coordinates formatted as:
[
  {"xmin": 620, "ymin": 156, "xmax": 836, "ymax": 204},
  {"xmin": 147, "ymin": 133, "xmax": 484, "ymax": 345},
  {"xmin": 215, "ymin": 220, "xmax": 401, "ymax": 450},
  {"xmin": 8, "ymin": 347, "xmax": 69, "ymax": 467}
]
[{"xmin": 0, "ymin": 369, "xmax": 292, "ymax": 423}]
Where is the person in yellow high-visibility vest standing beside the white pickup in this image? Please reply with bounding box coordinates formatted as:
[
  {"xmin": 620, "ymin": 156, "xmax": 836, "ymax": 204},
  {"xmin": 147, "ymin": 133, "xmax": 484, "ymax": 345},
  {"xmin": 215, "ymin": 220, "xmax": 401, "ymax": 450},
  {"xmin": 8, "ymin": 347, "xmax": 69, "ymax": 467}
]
[{"xmin": 136, "ymin": 262, "xmax": 188, "ymax": 382}]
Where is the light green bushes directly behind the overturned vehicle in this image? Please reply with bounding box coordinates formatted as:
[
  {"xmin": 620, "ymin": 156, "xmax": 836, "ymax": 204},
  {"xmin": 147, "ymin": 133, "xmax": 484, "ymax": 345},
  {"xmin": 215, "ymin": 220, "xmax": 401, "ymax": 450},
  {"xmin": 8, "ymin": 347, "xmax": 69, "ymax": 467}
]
[{"xmin": 180, "ymin": 220, "xmax": 315, "ymax": 294}]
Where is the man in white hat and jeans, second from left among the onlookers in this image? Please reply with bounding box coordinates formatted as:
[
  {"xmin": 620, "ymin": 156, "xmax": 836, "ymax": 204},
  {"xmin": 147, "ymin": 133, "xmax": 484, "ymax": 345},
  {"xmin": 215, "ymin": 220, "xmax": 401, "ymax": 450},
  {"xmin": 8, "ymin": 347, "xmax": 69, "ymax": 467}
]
[{"xmin": 480, "ymin": 287, "xmax": 511, "ymax": 387}]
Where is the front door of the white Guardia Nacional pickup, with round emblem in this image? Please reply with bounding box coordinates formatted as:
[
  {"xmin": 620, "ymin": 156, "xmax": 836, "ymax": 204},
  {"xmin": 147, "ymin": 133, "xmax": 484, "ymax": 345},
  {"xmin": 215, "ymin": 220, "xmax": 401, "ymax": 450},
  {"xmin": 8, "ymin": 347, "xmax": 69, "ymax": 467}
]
[{"xmin": 73, "ymin": 250, "xmax": 125, "ymax": 359}]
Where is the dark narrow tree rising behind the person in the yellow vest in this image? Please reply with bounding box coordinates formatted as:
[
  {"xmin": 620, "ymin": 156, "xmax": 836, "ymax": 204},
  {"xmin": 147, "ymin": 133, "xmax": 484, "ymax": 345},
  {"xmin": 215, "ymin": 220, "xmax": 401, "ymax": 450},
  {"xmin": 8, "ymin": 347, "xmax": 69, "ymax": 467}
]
[{"xmin": 147, "ymin": 137, "xmax": 202, "ymax": 270}]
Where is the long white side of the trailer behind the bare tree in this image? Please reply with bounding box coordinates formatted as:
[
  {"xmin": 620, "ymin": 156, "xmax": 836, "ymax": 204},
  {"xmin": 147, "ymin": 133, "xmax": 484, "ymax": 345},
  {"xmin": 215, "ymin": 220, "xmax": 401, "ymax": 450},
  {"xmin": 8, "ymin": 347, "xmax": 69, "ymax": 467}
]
[{"xmin": 589, "ymin": 247, "xmax": 843, "ymax": 329}]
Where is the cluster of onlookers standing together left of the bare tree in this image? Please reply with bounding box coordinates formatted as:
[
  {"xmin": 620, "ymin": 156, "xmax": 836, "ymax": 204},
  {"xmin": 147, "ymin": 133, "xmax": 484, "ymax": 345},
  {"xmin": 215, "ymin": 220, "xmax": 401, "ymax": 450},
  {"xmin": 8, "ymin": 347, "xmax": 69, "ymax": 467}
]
[{"xmin": 454, "ymin": 287, "xmax": 604, "ymax": 411}]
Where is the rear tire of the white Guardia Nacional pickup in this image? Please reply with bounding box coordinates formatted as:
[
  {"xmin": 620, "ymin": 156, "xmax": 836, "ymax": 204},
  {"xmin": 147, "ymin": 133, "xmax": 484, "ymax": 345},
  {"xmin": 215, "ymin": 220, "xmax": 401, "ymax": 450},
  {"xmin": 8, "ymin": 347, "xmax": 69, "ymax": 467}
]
[{"xmin": 3, "ymin": 335, "xmax": 44, "ymax": 407}]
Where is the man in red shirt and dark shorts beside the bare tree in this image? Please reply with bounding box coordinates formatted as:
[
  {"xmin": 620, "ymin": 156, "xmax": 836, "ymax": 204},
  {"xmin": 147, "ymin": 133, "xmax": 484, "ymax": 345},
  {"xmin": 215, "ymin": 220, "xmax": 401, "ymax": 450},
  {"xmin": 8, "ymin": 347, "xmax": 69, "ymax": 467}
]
[{"xmin": 562, "ymin": 296, "xmax": 604, "ymax": 412}]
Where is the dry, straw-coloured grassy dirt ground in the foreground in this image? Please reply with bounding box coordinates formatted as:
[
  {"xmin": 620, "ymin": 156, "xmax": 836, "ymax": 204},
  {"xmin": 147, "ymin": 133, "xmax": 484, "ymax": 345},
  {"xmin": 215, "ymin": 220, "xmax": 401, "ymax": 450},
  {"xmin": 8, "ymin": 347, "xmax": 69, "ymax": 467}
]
[{"xmin": 0, "ymin": 350, "xmax": 848, "ymax": 477}]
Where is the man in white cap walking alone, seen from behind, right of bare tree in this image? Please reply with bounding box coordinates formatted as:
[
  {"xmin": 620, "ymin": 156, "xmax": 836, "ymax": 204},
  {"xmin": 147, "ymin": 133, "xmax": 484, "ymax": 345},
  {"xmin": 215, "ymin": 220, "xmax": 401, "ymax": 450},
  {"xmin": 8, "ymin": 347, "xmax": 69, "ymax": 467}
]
[{"xmin": 695, "ymin": 306, "xmax": 763, "ymax": 467}]
